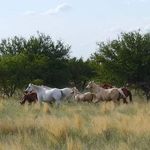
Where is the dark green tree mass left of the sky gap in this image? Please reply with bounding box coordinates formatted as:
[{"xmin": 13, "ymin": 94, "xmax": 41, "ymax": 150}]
[{"xmin": 0, "ymin": 32, "xmax": 92, "ymax": 96}]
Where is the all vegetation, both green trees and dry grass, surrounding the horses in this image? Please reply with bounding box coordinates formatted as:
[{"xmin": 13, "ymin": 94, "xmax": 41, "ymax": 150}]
[{"xmin": 0, "ymin": 31, "xmax": 150, "ymax": 150}]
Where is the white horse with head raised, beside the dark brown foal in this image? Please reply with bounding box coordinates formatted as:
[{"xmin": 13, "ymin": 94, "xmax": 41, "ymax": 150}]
[{"xmin": 25, "ymin": 83, "xmax": 72, "ymax": 105}]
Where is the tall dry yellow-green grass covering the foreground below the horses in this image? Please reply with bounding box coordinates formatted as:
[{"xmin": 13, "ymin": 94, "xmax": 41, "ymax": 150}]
[{"xmin": 0, "ymin": 98, "xmax": 150, "ymax": 150}]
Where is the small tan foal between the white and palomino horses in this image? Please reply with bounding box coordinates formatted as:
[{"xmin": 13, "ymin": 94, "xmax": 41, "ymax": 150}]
[{"xmin": 73, "ymin": 87, "xmax": 96, "ymax": 102}]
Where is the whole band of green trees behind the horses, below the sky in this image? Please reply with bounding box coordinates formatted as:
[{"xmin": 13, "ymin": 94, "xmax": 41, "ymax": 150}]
[{"xmin": 0, "ymin": 31, "xmax": 150, "ymax": 97}]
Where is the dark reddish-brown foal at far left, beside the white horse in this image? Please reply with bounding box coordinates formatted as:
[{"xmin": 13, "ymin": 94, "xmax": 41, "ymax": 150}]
[{"xmin": 20, "ymin": 92, "xmax": 37, "ymax": 105}]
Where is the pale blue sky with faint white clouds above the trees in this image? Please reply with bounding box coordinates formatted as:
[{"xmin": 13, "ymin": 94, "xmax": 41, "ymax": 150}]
[{"xmin": 0, "ymin": 0, "xmax": 150, "ymax": 59}]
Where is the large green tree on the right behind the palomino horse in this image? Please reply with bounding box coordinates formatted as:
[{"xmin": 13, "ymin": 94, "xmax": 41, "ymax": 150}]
[{"xmin": 91, "ymin": 31, "xmax": 150, "ymax": 85}]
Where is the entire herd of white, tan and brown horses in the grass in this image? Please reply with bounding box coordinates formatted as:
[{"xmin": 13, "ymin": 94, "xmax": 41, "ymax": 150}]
[{"xmin": 20, "ymin": 81, "xmax": 132, "ymax": 105}]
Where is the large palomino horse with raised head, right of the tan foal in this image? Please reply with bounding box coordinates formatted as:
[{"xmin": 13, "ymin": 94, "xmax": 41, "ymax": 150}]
[{"xmin": 86, "ymin": 81, "xmax": 127, "ymax": 103}]
